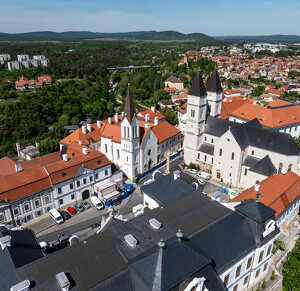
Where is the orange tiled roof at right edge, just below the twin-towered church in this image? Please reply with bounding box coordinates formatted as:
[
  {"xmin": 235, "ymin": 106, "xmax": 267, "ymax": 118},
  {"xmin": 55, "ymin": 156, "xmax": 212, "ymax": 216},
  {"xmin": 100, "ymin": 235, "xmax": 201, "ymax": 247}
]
[{"xmin": 231, "ymin": 172, "xmax": 300, "ymax": 218}]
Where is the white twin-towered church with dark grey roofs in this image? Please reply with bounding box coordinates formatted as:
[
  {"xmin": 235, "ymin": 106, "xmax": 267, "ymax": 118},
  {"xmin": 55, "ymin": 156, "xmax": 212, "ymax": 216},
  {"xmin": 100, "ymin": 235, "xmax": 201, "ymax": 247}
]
[{"xmin": 184, "ymin": 70, "xmax": 300, "ymax": 188}]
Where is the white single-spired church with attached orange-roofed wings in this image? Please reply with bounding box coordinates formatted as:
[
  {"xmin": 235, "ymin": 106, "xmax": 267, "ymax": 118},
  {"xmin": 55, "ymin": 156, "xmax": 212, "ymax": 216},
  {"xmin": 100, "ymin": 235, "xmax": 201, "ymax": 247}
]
[{"xmin": 60, "ymin": 88, "xmax": 181, "ymax": 179}]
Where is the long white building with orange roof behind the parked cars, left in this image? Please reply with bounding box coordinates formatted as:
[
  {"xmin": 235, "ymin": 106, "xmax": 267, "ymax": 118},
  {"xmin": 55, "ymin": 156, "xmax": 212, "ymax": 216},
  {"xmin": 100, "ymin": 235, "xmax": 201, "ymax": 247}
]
[{"xmin": 0, "ymin": 143, "xmax": 122, "ymax": 225}]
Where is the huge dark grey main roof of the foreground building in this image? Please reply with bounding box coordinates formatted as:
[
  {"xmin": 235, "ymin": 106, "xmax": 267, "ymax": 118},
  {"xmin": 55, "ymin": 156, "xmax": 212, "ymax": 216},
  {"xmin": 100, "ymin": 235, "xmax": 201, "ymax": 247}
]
[{"xmin": 7, "ymin": 175, "xmax": 275, "ymax": 291}]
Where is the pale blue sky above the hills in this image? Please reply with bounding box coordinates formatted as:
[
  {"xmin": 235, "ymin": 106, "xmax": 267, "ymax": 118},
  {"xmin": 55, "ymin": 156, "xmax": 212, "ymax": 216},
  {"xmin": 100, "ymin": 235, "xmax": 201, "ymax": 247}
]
[{"xmin": 0, "ymin": 0, "xmax": 300, "ymax": 36}]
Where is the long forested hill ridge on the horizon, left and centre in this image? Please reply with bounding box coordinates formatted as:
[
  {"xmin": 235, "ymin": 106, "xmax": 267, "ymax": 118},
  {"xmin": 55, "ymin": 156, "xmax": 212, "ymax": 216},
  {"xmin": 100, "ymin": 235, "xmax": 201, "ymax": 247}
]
[{"xmin": 0, "ymin": 30, "xmax": 215, "ymax": 42}]
